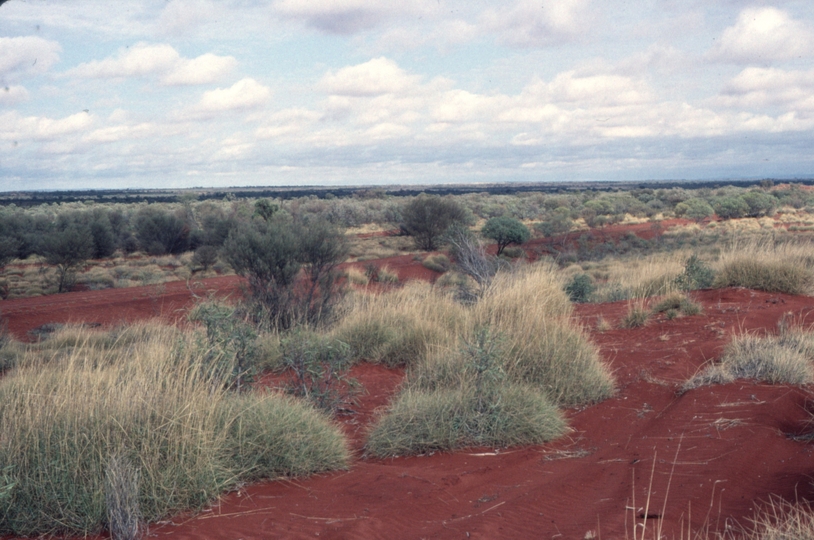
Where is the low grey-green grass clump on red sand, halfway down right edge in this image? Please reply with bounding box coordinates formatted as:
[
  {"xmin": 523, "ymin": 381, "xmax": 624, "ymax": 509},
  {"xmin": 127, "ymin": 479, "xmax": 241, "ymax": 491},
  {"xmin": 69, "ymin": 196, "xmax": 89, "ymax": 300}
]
[{"xmin": 683, "ymin": 330, "xmax": 814, "ymax": 391}]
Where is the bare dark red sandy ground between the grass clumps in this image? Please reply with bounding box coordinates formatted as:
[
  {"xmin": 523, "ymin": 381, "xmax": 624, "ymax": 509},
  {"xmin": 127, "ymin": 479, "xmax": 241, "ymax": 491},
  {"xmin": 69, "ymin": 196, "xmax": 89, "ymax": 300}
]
[{"xmin": 0, "ymin": 225, "xmax": 814, "ymax": 540}]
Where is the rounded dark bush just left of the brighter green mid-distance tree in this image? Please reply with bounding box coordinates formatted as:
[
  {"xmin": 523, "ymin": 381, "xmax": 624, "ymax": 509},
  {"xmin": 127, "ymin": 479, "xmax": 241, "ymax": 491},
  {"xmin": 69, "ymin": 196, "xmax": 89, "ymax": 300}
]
[{"xmin": 401, "ymin": 194, "xmax": 471, "ymax": 251}]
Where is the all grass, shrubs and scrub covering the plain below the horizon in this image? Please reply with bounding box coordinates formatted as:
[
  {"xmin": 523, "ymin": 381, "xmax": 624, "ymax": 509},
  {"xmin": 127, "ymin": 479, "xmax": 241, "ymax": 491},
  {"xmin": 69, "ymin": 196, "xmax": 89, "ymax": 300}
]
[{"xmin": 0, "ymin": 183, "xmax": 814, "ymax": 538}]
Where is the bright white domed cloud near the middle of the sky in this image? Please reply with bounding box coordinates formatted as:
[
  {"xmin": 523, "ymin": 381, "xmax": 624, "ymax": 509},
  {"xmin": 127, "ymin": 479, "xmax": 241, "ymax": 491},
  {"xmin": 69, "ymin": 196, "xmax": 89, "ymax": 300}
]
[{"xmin": 320, "ymin": 57, "xmax": 420, "ymax": 96}]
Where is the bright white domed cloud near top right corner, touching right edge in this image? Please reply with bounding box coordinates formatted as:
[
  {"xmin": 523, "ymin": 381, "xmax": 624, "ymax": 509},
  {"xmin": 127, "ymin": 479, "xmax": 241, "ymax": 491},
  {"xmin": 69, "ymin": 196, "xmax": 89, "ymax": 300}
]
[{"xmin": 708, "ymin": 7, "xmax": 814, "ymax": 64}]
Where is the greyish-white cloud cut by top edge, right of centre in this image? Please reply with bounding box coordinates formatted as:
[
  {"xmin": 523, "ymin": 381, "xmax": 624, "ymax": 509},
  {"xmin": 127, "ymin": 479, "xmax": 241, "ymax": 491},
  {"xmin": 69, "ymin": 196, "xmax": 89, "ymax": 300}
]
[{"xmin": 482, "ymin": 0, "xmax": 591, "ymax": 47}]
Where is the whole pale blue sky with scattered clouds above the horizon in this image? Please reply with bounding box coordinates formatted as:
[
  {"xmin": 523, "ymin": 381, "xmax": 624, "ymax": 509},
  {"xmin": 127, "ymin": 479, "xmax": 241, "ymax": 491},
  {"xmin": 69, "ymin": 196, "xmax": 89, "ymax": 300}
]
[{"xmin": 0, "ymin": 0, "xmax": 814, "ymax": 191}]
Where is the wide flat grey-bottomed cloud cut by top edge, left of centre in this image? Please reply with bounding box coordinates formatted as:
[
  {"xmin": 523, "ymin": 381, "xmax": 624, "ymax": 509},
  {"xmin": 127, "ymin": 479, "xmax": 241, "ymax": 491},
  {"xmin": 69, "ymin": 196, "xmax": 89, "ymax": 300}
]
[{"xmin": 274, "ymin": 0, "xmax": 433, "ymax": 35}]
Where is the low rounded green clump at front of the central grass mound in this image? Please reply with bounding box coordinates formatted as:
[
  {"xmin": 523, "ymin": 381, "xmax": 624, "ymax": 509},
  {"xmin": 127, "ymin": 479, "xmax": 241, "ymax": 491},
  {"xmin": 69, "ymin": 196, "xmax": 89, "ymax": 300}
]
[{"xmin": 367, "ymin": 383, "xmax": 565, "ymax": 457}]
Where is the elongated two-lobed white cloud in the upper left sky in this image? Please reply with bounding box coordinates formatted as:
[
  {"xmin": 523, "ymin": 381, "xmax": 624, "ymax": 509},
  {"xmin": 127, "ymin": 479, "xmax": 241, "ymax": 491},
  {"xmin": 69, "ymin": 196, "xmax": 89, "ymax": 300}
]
[{"xmin": 65, "ymin": 43, "xmax": 237, "ymax": 86}]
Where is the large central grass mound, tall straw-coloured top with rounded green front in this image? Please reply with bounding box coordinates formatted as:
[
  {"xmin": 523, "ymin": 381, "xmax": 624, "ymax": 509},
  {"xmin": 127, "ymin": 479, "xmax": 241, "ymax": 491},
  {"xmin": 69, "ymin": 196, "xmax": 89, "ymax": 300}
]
[{"xmin": 367, "ymin": 265, "xmax": 614, "ymax": 456}]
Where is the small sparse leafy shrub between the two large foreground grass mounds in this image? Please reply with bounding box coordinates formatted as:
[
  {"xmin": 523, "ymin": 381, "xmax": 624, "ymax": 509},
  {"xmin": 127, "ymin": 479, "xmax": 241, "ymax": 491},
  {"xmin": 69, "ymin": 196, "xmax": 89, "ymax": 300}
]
[{"xmin": 280, "ymin": 330, "xmax": 356, "ymax": 414}]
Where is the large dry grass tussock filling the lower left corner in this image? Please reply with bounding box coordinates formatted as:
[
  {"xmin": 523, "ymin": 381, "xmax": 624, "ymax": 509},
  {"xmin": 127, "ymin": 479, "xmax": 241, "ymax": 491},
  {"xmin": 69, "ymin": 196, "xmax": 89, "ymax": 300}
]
[{"xmin": 0, "ymin": 325, "xmax": 348, "ymax": 536}]
